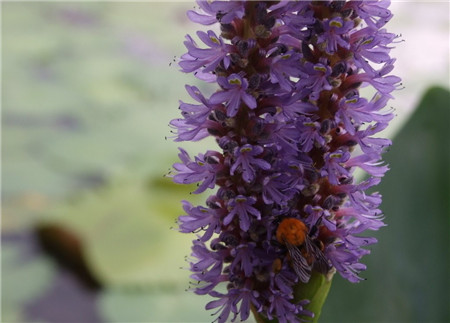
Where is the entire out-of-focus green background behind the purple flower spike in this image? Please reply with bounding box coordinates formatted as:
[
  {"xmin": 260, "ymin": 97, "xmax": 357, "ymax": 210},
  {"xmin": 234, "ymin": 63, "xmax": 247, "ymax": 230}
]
[{"xmin": 1, "ymin": 2, "xmax": 450, "ymax": 322}]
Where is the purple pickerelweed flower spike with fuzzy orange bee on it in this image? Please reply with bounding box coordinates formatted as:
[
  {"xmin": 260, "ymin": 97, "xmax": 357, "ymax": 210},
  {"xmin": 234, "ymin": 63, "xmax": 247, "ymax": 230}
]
[{"xmin": 171, "ymin": 0, "xmax": 400, "ymax": 323}]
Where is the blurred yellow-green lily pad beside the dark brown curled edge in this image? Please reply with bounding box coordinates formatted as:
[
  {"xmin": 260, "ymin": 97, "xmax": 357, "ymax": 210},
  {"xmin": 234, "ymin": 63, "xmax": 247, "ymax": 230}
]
[{"xmin": 40, "ymin": 178, "xmax": 204, "ymax": 286}]
